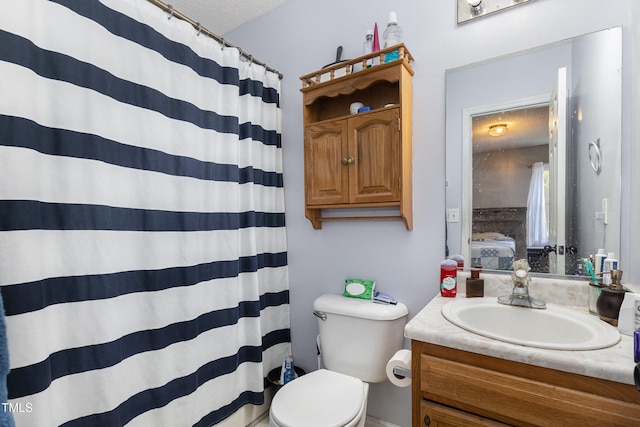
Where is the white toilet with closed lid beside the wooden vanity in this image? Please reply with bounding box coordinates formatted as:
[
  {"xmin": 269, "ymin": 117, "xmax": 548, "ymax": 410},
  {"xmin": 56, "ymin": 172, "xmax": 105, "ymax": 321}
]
[{"xmin": 269, "ymin": 294, "xmax": 409, "ymax": 427}]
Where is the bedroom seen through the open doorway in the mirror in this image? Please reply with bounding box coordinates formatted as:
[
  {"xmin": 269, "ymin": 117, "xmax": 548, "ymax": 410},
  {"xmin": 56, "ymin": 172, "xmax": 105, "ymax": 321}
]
[{"xmin": 471, "ymin": 104, "xmax": 549, "ymax": 272}]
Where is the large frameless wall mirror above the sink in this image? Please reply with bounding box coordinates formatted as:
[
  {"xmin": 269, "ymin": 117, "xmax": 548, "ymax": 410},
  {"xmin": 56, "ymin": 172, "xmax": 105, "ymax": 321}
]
[{"xmin": 445, "ymin": 28, "xmax": 622, "ymax": 275}]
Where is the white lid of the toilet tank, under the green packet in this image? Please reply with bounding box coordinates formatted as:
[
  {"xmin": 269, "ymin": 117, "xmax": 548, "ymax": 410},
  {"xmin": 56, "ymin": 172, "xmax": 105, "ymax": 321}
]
[{"xmin": 313, "ymin": 294, "xmax": 409, "ymax": 320}]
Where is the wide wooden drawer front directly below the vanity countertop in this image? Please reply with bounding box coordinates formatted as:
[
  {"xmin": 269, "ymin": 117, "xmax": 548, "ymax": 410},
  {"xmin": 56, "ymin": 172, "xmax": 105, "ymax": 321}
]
[{"xmin": 420, "ymin": 354, "xmax": 640, "ymax": 426}]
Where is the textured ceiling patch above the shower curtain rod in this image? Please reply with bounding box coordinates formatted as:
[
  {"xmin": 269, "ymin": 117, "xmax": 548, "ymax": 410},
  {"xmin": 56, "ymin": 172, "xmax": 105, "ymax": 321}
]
[{"xmin": 163, "ymin": 0, "xmax": 289, "ymax": 36}]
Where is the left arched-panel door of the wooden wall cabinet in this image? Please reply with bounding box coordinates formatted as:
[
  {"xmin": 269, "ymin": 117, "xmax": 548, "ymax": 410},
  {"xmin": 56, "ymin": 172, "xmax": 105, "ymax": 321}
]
[{"xmin": 304, "ymin": 120, "xmax": 350, "ymax": 205}]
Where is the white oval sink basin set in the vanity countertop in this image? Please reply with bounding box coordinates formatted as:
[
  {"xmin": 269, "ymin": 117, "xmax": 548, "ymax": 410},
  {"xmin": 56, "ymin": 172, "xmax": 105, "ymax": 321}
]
[{"xmin": 442, "ymin": 298, "xmax": 620, "ymax": 350}]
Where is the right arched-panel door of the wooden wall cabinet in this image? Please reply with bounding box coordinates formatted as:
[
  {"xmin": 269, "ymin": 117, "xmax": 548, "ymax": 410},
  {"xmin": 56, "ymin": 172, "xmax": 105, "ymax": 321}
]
[{"xmin": 348, "ymin": 108, "xmax": 401, "ymax": 203}]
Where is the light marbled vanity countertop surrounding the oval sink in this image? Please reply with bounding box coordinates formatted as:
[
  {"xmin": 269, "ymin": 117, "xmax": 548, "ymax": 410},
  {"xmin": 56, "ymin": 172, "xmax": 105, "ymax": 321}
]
[{"xmin": 404, "ymin": 279, "xmax": 635, "ymax": 385}]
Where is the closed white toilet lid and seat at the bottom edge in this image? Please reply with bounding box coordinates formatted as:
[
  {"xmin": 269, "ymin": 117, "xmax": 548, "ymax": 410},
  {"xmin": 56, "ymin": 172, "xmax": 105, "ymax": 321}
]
[{"xmin": 270, "ymin": 369, "xmax": 368, "ymax": 427}]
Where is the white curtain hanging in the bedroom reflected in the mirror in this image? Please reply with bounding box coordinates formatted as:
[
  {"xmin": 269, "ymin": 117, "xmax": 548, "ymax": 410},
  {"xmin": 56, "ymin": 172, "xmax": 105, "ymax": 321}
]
[{"xmin": 527, "ymin": 162, "xmax": 549, "ymax": 248}]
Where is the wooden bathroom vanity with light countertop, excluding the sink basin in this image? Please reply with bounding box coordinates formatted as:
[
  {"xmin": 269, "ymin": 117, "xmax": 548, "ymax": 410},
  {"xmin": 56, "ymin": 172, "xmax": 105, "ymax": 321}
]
[{"xmin": 405, "ymin": 276, "xmax": 640, "ymax": 427}]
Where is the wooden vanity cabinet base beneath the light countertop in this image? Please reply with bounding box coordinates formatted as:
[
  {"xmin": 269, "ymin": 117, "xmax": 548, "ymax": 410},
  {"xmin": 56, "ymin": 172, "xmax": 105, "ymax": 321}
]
[{"xmin": 412, "ymin": 341, "xmax": 640, "ymax": 427}]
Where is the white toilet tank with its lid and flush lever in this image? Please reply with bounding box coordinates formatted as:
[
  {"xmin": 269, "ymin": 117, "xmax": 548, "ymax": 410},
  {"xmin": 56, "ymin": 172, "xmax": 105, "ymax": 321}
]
[{"xmin": 313, "ymin": 294, "xmax": 409, "ymax": 383}]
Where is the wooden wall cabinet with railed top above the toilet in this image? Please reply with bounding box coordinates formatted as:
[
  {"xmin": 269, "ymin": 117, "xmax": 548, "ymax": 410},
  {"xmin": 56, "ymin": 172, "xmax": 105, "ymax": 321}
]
[{"xmin": 301, "ymin": 44, "xmax": 413, "ymax": 230}]
